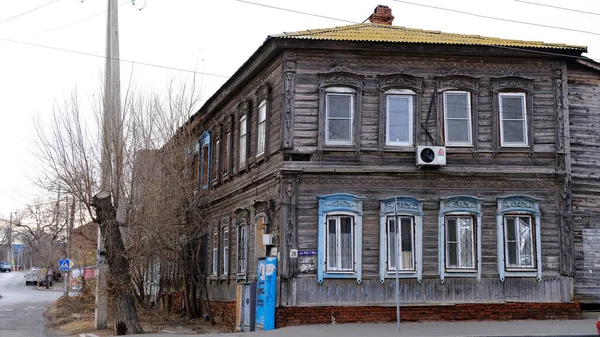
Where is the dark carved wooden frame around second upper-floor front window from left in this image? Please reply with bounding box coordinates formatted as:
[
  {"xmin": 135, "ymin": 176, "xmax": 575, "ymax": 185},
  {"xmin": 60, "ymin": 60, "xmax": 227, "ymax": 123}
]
[{"xmin": 377, "ymin": 71, "xmax": 423, "ymax": 152}]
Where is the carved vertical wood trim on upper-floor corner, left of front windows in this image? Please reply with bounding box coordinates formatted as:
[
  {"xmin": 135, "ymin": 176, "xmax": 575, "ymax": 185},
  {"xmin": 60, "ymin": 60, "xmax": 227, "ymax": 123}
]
[{"xmin": 281, "ymin": 51, "xmax": 297, "ymax": 149}]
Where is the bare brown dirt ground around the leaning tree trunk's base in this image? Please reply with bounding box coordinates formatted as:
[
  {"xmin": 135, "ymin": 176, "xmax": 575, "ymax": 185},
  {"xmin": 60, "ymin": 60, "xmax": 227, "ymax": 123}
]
[{"xmin": 44, "ymin": 294, "xmax": 229, "ymax": 336}]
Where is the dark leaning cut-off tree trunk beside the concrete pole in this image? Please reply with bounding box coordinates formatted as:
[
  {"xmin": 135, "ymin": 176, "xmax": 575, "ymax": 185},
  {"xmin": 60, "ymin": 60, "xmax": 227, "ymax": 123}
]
[{"xmin": 92, "ymin": 192, "xmax": 143, "ymax": 335}]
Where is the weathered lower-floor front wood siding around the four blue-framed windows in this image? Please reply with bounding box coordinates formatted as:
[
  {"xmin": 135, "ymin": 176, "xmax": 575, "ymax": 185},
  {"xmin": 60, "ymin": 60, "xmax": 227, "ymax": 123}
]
[{"xmin": 282, "ymin": 173, "xmax": 573, "ymax": 306}]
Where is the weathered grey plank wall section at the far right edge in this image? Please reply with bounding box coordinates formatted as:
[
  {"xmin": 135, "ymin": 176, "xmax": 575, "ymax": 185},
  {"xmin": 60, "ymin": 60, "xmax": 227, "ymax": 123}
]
[{"xmin": 568, "ymin": 64, "xmax": 600, "ymax": 303}]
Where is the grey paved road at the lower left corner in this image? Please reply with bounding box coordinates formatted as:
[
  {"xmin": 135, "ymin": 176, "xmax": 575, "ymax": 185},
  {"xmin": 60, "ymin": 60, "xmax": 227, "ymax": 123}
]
[{"xmin": 0, "ymin": 272, "xmax": 62, "ymax": 337}]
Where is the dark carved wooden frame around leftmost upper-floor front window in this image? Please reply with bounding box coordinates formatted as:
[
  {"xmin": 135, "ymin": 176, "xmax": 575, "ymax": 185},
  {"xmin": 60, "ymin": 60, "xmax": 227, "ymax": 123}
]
[{"xmin": 318, "ymin": 67, "xmax": 364, "ymax": 152}]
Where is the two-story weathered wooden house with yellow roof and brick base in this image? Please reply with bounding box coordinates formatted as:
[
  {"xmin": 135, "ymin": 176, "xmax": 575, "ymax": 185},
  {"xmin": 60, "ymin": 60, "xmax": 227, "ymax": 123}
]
[{"xmin": 178, "ymin": 6, "xmax": 600, "ymax": 326}]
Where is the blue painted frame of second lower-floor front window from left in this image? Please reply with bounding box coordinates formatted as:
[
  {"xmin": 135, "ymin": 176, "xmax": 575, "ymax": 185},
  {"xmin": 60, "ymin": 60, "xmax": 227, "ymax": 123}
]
[{"xmin": 379, "ymin": 196, "xmax": 423, "ymax": 283}]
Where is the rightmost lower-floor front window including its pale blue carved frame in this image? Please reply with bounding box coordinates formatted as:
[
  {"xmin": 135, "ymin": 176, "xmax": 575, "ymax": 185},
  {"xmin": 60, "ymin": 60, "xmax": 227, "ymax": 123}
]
[{"xmin": 497, "ymin": 196, "xmax": 542, "ymax": 281}]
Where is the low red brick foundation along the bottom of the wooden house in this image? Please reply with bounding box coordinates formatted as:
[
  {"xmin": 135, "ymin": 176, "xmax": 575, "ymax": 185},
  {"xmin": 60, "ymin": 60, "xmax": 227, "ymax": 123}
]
[{"xmin": 211, "ymin": 301, "xmax": 582, "ymax": 331}]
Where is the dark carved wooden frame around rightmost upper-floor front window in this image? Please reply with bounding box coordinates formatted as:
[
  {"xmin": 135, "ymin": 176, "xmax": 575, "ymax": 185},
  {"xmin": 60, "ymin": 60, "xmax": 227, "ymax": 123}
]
[{"xmin": 492, "ymin": 75, "xmax": 535, "ymax": 154}]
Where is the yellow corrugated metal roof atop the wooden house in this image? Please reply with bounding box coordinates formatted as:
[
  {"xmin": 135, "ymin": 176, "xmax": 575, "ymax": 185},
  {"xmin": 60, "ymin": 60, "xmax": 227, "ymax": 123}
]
[{"xmin": 271, "ymin": 23, "xmax": 587, "ymax": 52}]
